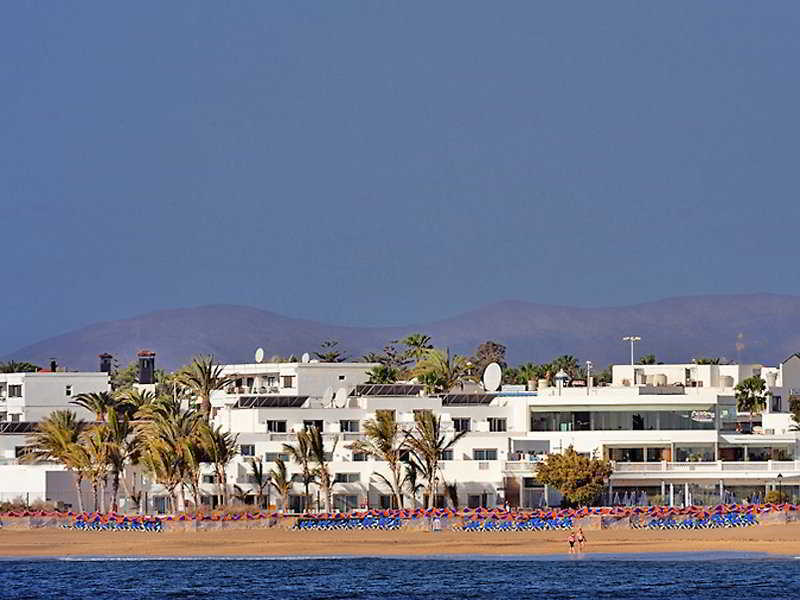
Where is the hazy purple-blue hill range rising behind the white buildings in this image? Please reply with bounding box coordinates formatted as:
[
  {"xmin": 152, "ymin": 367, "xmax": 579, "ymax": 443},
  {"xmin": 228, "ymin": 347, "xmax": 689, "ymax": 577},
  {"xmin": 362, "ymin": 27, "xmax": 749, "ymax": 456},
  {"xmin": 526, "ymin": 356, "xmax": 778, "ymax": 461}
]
[{"xmin": 2, "ymin": 294, "xmax": 800, "ymax": 370}]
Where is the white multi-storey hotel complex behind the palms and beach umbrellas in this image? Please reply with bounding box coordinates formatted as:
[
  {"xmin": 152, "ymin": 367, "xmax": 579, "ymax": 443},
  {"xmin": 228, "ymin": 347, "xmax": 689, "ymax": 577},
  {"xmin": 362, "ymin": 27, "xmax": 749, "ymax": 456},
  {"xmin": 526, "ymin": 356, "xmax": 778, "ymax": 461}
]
[{"xmin": 0, "ymin": 356, "xmax": 800, "ymax": 511}]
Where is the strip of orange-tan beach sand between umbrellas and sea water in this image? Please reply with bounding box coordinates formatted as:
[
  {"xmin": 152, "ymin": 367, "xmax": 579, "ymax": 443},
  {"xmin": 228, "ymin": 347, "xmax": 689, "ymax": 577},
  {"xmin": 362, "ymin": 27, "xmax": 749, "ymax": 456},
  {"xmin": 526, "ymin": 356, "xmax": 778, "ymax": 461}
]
[{"xmin": 0, "ymin": 523, "xmax": 800, "ymax": 557}]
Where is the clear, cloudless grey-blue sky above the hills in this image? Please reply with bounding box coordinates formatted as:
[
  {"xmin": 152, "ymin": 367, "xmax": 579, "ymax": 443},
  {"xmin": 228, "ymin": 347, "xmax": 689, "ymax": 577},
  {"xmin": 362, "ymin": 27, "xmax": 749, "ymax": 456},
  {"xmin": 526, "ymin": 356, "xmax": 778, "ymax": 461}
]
[{"xmin": 0, "ymin": 0, "xmax": 800, "ymax": 351}]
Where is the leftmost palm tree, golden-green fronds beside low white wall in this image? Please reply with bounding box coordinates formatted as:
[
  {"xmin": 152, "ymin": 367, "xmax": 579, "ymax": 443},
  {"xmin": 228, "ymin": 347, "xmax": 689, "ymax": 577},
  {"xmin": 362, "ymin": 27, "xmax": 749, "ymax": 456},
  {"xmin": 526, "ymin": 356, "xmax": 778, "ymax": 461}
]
[{"xmin": 23, "ymin": 410, "xmax": 87, "ymax": 512}]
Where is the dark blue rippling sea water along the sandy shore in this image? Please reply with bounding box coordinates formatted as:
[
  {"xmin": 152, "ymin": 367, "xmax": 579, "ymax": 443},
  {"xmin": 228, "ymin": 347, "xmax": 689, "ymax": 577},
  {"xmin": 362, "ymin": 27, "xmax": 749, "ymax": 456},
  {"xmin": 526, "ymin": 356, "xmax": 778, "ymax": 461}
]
[{"xmin": 0, "ymin": 548, "xmax": 800, "ymax": 600}]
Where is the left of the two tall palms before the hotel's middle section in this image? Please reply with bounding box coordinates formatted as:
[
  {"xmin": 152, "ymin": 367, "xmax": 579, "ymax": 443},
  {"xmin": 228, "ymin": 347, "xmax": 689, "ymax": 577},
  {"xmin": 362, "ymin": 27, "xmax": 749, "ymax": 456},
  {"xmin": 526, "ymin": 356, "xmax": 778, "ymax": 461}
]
[{"xmin": 348, "ymin": 411, "xmax": 407, "ymax": 508}]
